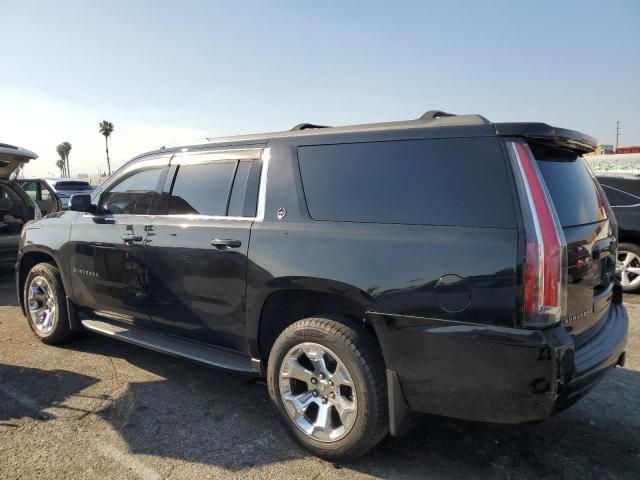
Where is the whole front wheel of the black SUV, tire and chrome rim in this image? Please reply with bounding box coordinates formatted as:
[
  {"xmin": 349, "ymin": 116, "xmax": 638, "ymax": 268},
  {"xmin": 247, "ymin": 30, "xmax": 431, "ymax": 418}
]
[{"xmin": 23, "ymin": 263, "xmax": 73, "ymax": 345}]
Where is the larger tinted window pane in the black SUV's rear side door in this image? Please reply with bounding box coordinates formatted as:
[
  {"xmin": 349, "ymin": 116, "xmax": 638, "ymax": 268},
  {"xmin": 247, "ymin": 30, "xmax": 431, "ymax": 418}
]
[{"xmin": 169, "ymin": 161, "xmax": 238, "ymax": 215}]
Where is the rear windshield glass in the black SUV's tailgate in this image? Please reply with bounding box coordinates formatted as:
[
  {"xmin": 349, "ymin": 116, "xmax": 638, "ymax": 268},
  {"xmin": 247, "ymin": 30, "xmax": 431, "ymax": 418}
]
[{"xmin": 531, "ymin": 144, "xmax": 604, "ymax": 227}]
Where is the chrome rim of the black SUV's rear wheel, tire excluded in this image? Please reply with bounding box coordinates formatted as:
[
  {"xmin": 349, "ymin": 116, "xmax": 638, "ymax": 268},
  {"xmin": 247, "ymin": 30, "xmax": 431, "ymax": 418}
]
[{"xmin": 279, "ymin": 342, "xmax": 358, "ymax": 442}]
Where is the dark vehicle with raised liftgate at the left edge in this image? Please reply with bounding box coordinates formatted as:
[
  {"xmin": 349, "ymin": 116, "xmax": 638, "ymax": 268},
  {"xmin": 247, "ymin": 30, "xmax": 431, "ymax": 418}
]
[{"xmin": 0, "ymin": 143, "xmax": 42, "ymax": 273}]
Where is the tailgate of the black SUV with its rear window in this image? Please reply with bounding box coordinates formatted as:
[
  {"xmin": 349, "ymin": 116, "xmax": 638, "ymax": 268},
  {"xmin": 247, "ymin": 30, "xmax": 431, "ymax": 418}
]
[{"xmin": 529, "ymin": 142, "xmax": 617, "ymax": 344}]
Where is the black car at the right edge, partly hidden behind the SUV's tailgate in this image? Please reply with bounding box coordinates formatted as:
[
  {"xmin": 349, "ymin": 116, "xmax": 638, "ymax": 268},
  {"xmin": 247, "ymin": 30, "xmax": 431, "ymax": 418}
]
[{"xmin": 598, "ymin": 174, "xmax": 640, "ymax": 292}]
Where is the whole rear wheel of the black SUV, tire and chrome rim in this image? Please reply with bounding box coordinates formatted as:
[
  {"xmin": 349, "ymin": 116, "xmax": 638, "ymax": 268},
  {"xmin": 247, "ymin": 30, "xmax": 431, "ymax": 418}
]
[{"xmin": 267, "ymin": 317, "xmax": 388, "ymax": 460}]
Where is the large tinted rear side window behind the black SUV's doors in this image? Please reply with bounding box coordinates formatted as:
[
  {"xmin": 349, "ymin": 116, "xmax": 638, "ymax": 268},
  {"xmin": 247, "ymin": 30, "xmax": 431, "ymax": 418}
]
[{"xmin": 298, "ymin": 138, "xmax": 515, "ymax": 228}]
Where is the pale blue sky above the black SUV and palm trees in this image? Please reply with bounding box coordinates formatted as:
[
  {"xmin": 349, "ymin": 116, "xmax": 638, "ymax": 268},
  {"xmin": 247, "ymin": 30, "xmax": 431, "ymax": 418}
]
[{"xmin": 0, "ymin": 0, "xmax": 640, "ymax": 176}]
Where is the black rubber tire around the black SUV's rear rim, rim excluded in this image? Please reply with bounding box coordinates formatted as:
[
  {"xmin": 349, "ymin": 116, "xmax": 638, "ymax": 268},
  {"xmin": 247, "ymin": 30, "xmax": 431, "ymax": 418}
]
[{"xmin": 267, "ymin": 317, "xmax": 389, "ymax": 461}]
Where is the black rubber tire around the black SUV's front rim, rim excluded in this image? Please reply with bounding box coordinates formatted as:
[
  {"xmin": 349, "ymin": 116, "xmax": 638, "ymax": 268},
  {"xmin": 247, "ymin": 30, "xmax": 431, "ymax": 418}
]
[{"xmin": 22, "ymin": 263, "xmax": 74, "ymax": 345}]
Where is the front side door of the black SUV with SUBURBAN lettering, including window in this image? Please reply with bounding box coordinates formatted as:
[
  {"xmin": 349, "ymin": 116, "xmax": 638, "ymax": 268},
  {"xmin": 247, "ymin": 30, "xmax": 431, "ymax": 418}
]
[{"xmin": 69, "ymin": 156, "xmax": 168, "ymax": 323}]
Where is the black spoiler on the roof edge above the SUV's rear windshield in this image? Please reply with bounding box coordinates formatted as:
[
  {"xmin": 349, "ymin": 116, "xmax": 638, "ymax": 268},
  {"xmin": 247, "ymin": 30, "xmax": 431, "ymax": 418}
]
[{"xmin": 494, "ymin": 122, "xmax": 598, "ymax": 154}]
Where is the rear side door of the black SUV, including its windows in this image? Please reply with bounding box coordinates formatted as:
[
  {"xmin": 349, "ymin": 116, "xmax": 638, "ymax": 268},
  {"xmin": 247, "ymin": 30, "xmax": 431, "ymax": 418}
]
[{"xmin": 146, "ymin": 148, "xmax": 261, "ymax": 349}]
